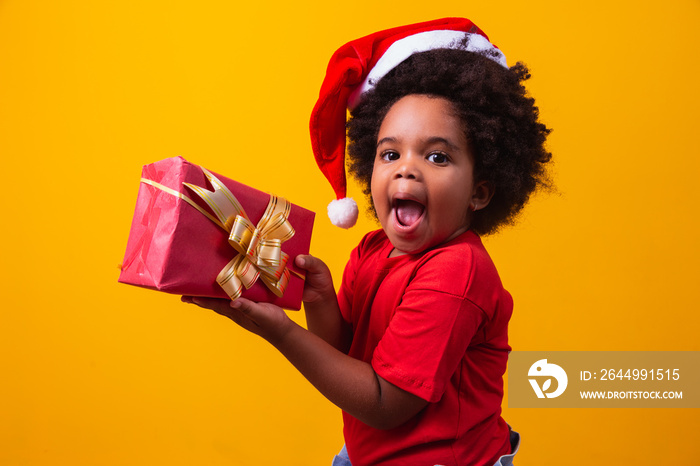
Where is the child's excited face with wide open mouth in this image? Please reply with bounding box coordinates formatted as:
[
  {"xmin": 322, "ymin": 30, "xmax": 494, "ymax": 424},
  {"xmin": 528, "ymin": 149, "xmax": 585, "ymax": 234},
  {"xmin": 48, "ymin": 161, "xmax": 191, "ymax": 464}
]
[{"xmin": 371, "ymin": 95, "xmax": 476, "ymax": 255}]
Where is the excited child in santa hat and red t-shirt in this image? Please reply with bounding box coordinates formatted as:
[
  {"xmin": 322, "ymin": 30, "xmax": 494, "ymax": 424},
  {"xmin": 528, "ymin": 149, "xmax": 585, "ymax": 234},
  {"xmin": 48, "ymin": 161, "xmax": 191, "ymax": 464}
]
[{"xmin": 183, "ymin": 18, "xmax": 550, "ymax": 466}]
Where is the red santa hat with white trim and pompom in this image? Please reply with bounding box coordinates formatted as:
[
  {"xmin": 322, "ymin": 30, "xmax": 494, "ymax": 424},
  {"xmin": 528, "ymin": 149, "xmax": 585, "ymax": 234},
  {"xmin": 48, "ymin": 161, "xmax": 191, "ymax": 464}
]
[{"xmin": 310, "ymin": 18, "xmax": 508, "ymax": 228}]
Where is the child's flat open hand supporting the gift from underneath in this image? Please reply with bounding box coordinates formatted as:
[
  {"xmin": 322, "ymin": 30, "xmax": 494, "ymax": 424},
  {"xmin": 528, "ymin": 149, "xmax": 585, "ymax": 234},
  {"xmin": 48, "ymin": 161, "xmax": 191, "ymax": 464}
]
[{"xmin": 182, "ymin": 296, "xmax": 295, "ymax": 345}]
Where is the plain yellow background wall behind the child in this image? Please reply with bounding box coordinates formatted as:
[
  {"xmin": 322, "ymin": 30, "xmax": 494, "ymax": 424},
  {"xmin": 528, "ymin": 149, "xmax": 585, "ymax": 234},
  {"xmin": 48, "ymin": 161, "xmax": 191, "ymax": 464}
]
[{"xmin": 0, "ymin": 0, "xmax": 700, "ymax": 466}]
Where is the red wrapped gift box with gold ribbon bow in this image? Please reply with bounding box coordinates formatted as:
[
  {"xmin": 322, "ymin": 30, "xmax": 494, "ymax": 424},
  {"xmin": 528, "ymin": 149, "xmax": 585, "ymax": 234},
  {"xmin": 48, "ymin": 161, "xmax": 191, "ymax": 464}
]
[{"xmin": 119, "ymin": 157, "xmax": 315, "ymax": 309}]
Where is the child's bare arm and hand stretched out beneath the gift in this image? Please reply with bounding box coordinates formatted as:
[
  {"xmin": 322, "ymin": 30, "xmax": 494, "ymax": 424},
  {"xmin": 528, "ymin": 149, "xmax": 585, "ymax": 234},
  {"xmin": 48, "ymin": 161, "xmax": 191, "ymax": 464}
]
[{"xmin": 183, "ymin": 297, "xmax": 427, "ymax": 429}]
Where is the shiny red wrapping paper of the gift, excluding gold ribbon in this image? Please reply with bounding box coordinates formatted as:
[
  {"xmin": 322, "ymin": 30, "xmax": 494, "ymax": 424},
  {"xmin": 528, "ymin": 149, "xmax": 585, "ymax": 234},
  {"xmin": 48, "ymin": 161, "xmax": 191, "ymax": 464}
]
[{"xmin": 119, "ymin": 157, "xmax": 315, "ymax": 310}]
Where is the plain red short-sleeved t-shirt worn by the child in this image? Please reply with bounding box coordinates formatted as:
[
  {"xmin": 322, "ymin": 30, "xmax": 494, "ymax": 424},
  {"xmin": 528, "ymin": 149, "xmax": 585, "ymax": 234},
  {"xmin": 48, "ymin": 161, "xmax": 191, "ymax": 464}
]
[{"xmin": 338, "ymin": 230, "xmax": 513, "ymax": 466}]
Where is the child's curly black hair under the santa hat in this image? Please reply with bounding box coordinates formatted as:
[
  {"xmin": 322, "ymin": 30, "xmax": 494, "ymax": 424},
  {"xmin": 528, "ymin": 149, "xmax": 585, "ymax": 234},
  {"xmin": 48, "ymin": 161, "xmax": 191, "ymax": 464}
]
[{"xmin": 347, "ymin": 39, "xmax": 552, "ymax": 235}]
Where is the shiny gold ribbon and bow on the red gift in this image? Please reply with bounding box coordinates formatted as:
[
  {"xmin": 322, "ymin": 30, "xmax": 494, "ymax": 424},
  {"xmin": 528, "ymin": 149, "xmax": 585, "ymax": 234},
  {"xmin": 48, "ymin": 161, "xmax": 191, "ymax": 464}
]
[{"xmin": 141, "ymin": 168, "xmax": 303, "ymax": 300}]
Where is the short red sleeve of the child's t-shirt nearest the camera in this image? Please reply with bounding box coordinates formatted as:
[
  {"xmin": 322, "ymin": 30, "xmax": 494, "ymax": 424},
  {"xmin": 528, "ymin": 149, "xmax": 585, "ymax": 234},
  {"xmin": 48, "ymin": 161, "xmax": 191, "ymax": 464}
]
[{"xmin": 372, "ymin": 256, "xmax": 486, "ymax": 402}]
